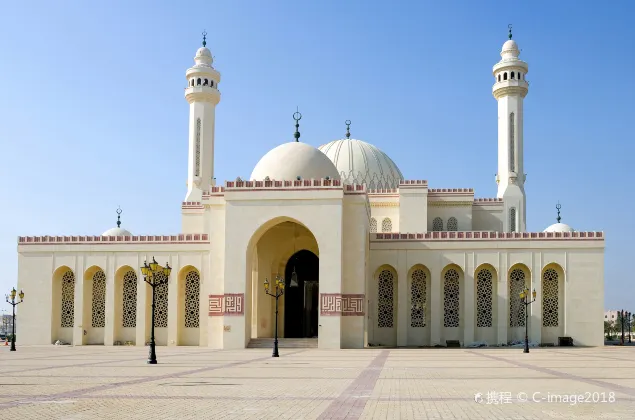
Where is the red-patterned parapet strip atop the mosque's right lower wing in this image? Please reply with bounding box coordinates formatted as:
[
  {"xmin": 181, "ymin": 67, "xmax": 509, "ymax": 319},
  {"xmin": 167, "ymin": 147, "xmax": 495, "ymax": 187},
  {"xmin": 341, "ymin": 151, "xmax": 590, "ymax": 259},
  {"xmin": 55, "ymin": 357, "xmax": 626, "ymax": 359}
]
[{"xmin": 375, "ymin": 232, "xmax": 604, "ymax": 241}]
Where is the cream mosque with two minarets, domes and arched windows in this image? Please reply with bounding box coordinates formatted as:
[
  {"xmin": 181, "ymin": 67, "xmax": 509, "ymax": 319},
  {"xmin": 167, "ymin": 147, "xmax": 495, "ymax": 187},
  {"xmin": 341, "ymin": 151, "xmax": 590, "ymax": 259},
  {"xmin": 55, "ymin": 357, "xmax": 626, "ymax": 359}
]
[{"xmin": 18, "ymin": 31, "xmax": 604, "ymax": 349}]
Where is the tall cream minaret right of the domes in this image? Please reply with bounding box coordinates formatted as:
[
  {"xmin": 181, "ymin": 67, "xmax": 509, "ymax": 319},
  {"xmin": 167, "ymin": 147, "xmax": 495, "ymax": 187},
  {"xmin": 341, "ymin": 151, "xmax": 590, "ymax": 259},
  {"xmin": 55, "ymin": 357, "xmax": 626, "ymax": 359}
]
[{"xmin": 492, "ymin": 25, "xmax": 529, "ymax": 232}]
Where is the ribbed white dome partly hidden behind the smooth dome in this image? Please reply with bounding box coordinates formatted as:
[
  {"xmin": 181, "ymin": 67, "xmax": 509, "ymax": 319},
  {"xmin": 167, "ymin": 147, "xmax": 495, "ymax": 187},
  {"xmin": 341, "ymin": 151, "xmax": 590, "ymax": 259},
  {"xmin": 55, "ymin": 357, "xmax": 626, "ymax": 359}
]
[{"xmin": 319, "ymin": 139, "xmax": 403, "ymax": 189}]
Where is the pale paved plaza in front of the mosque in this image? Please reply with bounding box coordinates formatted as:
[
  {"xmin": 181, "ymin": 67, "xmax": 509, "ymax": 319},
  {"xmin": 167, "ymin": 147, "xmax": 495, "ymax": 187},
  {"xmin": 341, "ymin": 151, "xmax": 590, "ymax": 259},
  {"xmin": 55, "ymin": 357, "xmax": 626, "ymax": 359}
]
[{"xmin": 0, "ymin": 346, "xmax": 635, "ymax": 420}]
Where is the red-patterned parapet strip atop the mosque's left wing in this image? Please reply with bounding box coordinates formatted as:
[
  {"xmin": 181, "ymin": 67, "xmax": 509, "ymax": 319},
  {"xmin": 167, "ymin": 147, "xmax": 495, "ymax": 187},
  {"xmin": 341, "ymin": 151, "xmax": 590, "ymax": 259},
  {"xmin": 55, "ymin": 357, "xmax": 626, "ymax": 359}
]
[{"xmin": 18, "ymin": 233, "xmax": 209, "ymax": 245}]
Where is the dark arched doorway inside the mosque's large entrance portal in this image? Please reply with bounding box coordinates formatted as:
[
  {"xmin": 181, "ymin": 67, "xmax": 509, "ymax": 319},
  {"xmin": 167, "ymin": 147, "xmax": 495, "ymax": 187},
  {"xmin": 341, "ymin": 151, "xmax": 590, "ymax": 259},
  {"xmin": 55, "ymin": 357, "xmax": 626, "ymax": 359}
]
[{"xmin": 284, "ymin": 249, "xmax": 320, "ymax": 338}]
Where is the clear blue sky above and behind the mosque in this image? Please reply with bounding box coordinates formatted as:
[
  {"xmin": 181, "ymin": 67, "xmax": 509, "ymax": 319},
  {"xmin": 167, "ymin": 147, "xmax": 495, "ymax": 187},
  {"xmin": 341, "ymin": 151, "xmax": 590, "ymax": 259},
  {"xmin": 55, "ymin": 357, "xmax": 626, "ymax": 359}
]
[{"xmin": 0, "ymin": 0, "xmax": 635, "ymax": 312}]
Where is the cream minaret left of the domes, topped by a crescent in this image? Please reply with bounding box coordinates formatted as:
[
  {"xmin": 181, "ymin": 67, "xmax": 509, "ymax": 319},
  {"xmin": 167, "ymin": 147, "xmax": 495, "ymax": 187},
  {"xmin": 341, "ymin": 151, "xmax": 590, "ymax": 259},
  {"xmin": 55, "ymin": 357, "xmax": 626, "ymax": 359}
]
[{"xmin": 185, "ymin": 32, "xmax": 220, "ymax": 202}]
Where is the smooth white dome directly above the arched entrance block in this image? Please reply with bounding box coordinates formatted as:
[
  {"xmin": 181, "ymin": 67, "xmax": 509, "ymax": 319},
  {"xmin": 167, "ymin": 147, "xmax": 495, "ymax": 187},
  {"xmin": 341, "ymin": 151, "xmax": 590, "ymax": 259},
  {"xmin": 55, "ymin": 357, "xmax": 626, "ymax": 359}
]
[{"xmin": 249, "ymin": 141, "xmax": 340, "ymax": 181}]
